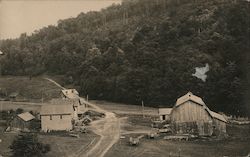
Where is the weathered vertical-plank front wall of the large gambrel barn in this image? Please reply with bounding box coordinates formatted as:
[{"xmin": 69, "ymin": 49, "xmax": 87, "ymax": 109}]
[{"xmin": 171, "ymin": 101, "xmax": 213, "ymax": 135}]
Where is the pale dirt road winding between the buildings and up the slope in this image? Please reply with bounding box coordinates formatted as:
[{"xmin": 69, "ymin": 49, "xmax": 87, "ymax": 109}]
[{"xmin": 45, "ymin": 78, "xmax": 120, "ymax": 157}]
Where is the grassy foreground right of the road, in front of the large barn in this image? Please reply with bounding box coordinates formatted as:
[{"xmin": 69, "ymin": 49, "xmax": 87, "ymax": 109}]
[{"xmin": 105, "ymin": 125, "xmax": 250, "ymax": 157}]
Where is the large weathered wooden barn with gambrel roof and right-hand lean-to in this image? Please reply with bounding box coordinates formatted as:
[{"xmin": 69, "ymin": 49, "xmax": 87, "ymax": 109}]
[{"xmin": 170, "ymin": 92, "xmax": 227, "ymax": 136}]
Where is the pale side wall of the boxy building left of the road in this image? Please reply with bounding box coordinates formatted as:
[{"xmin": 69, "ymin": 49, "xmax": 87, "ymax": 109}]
[{"xmin": 41, "ymin": 115, "xmax": 72, "ymax": 132}]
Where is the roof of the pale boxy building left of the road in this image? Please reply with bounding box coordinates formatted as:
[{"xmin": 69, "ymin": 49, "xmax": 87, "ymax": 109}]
[{"xmin": 40, "ymin": 104, "xmax": 74, "ymax": 115}]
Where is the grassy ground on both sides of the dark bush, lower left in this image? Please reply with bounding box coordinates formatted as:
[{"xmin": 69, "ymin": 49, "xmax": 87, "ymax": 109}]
[{"xmin": 0, "ymin": 127, "xmax": 99, "ymax": 157}]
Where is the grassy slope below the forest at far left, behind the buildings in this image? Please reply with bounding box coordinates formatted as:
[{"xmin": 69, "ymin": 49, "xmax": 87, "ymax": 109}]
[{"xmin": 0, "ymin": 76, "xmax": 60, "ymax": 102}]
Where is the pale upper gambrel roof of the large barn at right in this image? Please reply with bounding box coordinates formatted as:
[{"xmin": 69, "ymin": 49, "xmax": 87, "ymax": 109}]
[{"xmin": 176, "ymin": 92, "xmax": 205, "ymax": 106}]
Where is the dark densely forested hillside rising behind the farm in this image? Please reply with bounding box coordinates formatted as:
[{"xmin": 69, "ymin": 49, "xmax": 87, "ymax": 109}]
[{"xmin": 0, "ymin": 0, "xmax": 250, "ymax": 115}]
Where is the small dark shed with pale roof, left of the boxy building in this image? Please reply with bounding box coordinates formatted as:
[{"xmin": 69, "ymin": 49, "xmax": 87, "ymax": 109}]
[{"xmin": 10, "ymin": 112, "xmax": 35, "ymax": 131}]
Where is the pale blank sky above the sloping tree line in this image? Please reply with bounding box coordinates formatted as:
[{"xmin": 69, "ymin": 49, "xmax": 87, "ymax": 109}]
[{"xmin": 0, "ymin": 0, "xmax": 120, "ymax": 39}]
